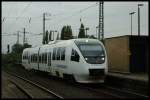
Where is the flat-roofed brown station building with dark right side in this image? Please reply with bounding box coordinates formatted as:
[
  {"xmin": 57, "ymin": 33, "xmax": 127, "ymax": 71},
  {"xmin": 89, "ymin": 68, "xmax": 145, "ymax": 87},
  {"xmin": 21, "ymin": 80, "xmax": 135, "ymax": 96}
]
[{"xmin": 104, "ymin": 35, "xmax": 149, "ymax": 73}]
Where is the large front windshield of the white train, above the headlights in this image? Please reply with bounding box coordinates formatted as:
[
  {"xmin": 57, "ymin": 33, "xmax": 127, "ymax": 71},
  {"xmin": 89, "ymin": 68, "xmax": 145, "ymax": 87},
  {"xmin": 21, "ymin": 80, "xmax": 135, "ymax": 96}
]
[{"xmin": 77, "ymin": 44, "xmax": 105, "ymax": 64}]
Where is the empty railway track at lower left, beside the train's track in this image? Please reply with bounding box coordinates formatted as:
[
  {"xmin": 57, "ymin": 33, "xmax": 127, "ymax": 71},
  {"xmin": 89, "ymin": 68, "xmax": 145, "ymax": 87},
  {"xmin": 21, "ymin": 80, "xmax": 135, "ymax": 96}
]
[{"xmin": 5, "ymin": 71, "xmax": 63, "ymax": 99}]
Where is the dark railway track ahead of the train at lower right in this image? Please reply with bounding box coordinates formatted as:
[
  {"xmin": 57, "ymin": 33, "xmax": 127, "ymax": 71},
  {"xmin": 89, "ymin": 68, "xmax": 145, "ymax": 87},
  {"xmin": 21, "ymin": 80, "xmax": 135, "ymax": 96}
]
[{"xmin": 73, "ymin": 84, "xmax": 148, "ymax": 98}]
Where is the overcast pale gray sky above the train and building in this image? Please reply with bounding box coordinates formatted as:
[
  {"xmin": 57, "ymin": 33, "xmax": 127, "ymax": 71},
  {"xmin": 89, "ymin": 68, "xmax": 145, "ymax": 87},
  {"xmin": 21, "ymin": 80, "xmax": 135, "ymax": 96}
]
[{"xmin": 1, "ymin": 2, "xmax": 149, "ymax": 53}]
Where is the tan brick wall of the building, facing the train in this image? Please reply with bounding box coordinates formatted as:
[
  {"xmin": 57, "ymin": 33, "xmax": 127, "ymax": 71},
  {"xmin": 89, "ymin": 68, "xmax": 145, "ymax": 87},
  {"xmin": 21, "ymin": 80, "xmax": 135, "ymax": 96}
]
[{"xmin": 104, "ymin": 36, "xmax": 130, "ymax": 73}]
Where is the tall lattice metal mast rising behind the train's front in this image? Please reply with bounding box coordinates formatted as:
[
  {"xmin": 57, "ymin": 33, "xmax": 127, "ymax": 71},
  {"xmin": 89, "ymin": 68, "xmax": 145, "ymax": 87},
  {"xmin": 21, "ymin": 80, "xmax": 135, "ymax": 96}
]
[{"xmin": 98, "ymin": 1, "xmax": 104, "ymax": 40}]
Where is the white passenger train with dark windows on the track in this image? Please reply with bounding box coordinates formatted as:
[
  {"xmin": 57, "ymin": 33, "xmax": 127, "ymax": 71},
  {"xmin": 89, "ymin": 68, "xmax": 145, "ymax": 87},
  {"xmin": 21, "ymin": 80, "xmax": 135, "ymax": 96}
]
[{"xmin": 22, "ymin": 39, "xmax": 108, "ymax": 83}]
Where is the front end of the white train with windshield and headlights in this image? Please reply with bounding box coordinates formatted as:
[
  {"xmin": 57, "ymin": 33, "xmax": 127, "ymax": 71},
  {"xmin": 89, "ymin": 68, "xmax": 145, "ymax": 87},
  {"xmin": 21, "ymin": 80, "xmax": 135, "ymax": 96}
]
[{"xmin": 75, "ymin": 39, "xmax": 108, "ymax": 83}]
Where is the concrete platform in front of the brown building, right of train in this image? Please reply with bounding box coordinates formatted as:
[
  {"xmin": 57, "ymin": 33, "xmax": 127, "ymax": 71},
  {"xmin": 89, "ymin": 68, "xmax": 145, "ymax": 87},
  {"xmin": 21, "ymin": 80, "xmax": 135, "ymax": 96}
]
[{"xmin": 105, "ymin": 72, "xmax": 149, "ymax": 95}]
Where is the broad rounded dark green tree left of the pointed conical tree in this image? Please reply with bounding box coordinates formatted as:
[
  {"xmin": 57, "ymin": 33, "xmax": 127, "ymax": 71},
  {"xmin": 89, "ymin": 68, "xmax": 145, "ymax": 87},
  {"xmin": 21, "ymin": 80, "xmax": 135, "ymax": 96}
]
[{"xmin": 61, "ymin": 25, "xmax": 73, "ymax": 40}]
